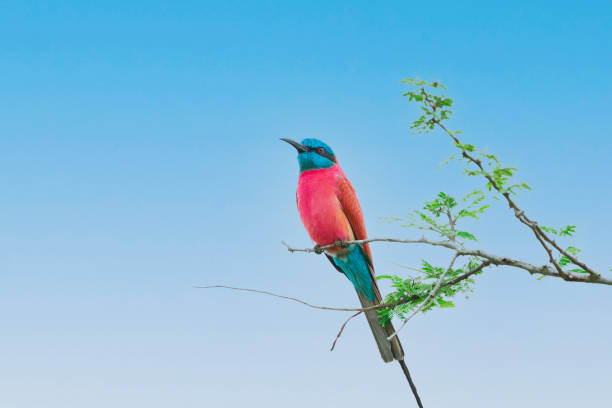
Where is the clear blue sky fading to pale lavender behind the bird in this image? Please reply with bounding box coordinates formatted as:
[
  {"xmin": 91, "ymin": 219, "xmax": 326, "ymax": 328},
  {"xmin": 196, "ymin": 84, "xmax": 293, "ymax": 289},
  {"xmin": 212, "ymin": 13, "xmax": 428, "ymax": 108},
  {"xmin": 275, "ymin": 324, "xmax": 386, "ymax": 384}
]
[{"xmin": 0, "ymin": 1, "xmax": 612, "ymax": 408}]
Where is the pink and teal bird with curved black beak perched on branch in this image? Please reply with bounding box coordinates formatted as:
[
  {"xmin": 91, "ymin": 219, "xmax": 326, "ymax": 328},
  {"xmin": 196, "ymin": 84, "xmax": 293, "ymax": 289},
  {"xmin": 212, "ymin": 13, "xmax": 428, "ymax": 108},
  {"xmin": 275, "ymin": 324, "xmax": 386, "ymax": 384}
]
[{"xmin": 281, "ymin": 138, "xmax": 422, "ymax": 407}]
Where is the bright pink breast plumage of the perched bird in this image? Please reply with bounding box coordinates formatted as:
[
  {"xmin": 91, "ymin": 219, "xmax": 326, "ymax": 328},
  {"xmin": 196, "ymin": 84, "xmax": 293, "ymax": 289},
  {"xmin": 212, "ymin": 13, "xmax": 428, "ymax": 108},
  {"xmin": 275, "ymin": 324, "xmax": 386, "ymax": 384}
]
[{"xmin": 297, "ymin": 165, "xmax": 354, "ymax": 249}]
